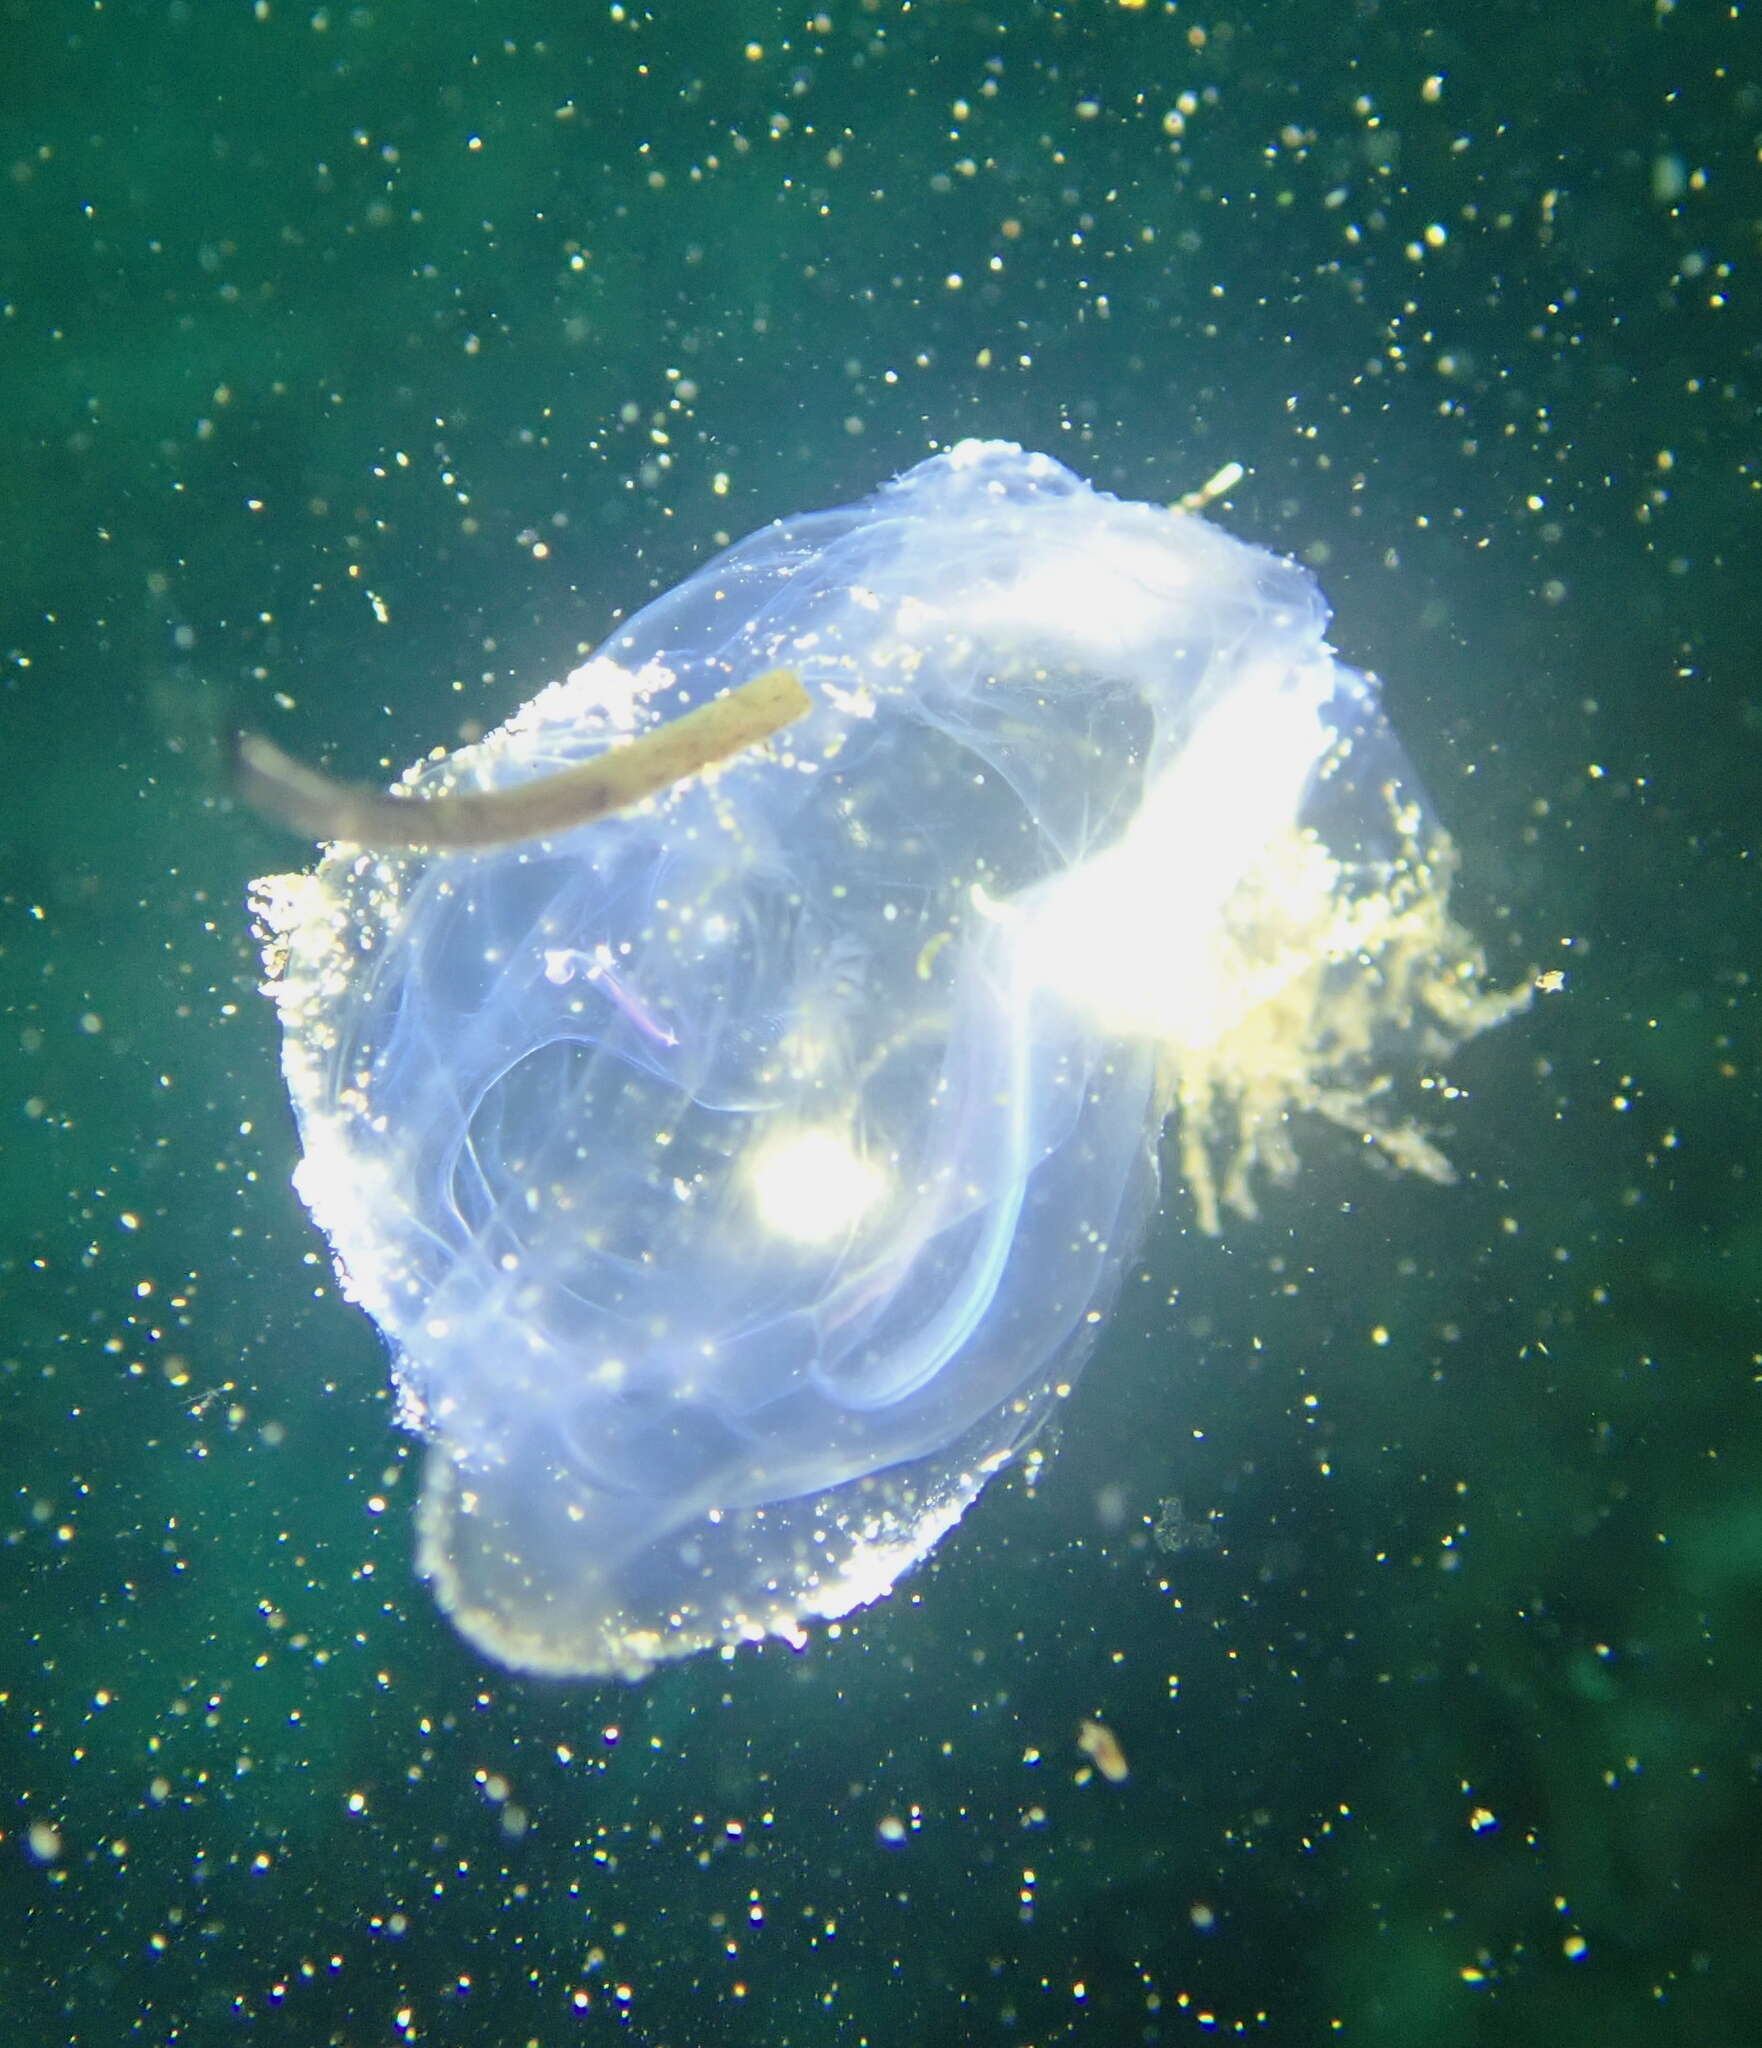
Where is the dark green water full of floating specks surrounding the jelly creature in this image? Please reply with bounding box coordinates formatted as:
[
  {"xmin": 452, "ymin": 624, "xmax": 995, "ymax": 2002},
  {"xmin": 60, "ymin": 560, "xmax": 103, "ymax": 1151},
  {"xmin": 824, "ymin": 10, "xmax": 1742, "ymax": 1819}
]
[{"xmin": 0, "ymin": 0, "xmax": 1762, "ymax": 2048}]
